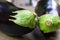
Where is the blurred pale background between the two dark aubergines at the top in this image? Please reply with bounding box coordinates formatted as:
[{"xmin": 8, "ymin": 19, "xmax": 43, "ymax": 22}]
[{"xmin": 7, "ymin": 0, "xmax": 39, "ymax": 11}]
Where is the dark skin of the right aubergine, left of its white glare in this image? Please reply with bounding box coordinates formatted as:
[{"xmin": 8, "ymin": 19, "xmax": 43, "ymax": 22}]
[{"xmin": 35, "ymin": 0, "xmax": 48, "ymax": 16}]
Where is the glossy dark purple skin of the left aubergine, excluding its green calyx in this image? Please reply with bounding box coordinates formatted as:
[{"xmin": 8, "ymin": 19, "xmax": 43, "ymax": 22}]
[{"xmin": 0, "ymin": 2, "xmax": 33, "ymax": 37}]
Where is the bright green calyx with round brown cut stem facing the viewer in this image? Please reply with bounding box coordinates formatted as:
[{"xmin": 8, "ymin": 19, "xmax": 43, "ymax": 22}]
[{"xmin": 39, "ymin": 14, "xmax": 60, "ymax": 33}]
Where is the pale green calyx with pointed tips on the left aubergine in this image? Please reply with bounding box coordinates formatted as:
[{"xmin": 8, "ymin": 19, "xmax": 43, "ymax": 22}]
[{"xmin": 9, "ymin": 10, "xmax": 36, "ymax": 29}]
